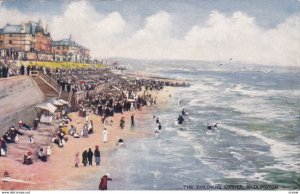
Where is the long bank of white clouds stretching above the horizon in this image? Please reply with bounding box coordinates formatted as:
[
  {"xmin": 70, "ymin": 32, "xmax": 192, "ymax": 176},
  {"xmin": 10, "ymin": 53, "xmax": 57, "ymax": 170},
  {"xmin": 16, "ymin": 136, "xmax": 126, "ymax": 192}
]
[{"xmin": 0, "ymin": 1, "xmax": 300, "ymax": 66}]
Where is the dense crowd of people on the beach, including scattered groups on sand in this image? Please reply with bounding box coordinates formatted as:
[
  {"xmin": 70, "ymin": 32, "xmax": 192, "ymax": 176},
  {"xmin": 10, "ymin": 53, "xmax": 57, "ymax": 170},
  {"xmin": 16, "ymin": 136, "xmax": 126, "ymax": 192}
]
[{"xmin": 0, "ymin": 62, "xmax": 188, "ymax": 190}]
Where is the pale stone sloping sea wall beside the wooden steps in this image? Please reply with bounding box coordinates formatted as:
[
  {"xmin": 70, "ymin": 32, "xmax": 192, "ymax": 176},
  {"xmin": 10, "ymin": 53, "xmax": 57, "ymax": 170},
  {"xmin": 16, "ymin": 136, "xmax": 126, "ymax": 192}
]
[{"xmin": 0, "ymin": 76, "xmax": 44, "ymax": 136}]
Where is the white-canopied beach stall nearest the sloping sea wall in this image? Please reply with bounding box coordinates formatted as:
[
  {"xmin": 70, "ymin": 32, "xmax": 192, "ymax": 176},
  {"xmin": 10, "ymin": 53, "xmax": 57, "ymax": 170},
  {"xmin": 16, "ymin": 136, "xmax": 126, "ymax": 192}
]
[{"xmin": 34, "ymin": 102, "xmax": 57, "ymax": 123}]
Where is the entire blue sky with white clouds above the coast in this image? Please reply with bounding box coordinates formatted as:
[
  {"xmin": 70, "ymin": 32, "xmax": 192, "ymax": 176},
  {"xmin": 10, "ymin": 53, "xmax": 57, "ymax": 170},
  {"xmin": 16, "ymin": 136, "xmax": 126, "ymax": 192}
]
[{"xmin": 0, "ymin": 0, "xmax": 300, "ymax": 66}]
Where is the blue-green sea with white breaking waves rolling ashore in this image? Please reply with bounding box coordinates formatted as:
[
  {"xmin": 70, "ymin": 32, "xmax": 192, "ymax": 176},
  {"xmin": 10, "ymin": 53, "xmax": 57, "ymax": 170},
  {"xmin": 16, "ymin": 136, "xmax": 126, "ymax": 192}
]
[{"xmin": 83, "ymin": 61, "xmax": 300, "ymax": 190}]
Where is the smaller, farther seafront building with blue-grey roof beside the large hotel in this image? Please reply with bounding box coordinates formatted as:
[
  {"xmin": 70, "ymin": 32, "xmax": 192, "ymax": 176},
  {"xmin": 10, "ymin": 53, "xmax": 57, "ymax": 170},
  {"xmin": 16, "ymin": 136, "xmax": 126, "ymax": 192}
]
[{"xmin": 52, "ymin": 35, "xmax": 90, "ymax": 63}]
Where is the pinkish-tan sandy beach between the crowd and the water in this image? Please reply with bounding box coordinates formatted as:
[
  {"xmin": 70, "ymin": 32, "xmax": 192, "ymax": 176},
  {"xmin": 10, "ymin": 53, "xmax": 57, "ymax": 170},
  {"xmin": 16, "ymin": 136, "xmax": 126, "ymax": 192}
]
[{"xmin": 0, "ymin": 87, "xmax": 176, "ymax": 190}]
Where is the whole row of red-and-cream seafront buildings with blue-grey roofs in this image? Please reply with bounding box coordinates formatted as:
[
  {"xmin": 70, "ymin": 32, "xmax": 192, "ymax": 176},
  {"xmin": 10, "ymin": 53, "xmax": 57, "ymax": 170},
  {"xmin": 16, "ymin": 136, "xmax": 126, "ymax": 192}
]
[{"xmin": 0, "ymin": 20, "xmax": 90, "ymax": 63}]
